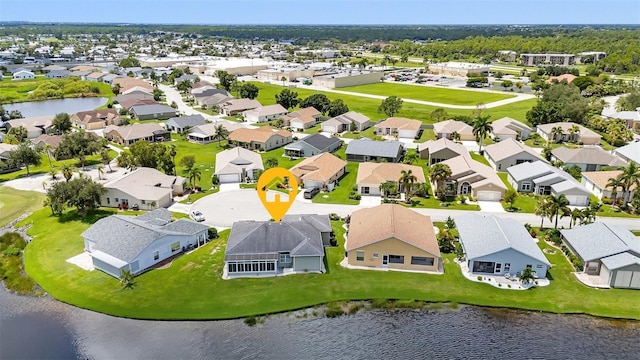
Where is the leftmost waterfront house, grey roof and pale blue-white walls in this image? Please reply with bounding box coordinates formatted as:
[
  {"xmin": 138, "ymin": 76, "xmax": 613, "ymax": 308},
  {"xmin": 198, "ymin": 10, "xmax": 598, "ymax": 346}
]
[{"xmin": 82, "ymin": 209, "xmax": 208, "ymax": 279}]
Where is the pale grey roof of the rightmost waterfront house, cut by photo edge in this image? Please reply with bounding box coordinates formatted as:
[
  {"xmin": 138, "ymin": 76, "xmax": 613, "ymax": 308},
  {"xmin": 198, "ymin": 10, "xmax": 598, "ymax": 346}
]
[{"xmin": 560, "ymin": 221, "xmax": 640, "ymax": 261}]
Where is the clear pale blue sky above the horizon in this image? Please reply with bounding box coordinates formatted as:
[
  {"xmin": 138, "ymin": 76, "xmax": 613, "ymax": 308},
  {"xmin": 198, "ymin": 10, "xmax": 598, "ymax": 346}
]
[{"xmin": 0, "ymin": 0, "xmax": 640, "ymax": 25}]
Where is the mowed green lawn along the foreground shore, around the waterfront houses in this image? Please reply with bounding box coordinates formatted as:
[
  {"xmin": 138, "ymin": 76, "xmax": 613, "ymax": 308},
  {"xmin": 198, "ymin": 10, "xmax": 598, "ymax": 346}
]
[{"xmin": 25, "ymin": 209, "xmax": 640, "ymax": 319}]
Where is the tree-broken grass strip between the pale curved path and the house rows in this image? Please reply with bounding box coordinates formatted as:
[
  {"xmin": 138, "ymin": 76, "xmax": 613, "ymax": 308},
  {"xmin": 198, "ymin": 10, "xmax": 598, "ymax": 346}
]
[{"xmin": 248, "ymin": 82, "xmax": 537, "ymax": 124}]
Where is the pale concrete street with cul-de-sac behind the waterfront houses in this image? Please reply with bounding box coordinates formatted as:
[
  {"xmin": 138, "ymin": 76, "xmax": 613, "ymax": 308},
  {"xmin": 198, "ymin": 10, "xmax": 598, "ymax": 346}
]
[{"xmin": 182, "ymin": 189, "xmax": 640, "ymax": 230}]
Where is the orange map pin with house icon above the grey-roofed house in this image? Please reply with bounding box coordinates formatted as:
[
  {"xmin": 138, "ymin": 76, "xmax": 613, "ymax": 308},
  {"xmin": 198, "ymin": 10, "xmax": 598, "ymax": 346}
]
[{"xmin": 256, "ymin": 167, "xmax": 298, "ymax": 222}]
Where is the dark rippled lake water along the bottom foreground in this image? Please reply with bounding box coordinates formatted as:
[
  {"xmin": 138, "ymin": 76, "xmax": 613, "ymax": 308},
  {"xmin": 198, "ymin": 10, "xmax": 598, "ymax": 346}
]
[{"xmin": 0, "ymin": 290, "xmax": 640, "ymax": 359}]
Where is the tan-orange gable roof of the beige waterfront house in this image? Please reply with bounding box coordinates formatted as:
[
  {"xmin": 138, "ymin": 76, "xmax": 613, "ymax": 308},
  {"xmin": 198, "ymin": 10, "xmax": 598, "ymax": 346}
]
[{"xmin": 345, "ymin": 204, "xmax": 440, "ymax": 257}]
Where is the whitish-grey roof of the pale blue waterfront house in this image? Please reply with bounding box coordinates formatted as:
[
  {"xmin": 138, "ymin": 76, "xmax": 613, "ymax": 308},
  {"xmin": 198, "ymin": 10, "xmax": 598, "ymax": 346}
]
[{"xmin": 454, "ymin": 214, "xmax": 550, "ymax": 265}]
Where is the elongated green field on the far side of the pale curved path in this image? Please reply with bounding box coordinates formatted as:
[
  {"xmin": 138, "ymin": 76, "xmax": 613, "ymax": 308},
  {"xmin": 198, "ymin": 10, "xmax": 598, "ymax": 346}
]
[{"xmin": 338, "ymin": 82, "xmax": 514, "ymax": 106}]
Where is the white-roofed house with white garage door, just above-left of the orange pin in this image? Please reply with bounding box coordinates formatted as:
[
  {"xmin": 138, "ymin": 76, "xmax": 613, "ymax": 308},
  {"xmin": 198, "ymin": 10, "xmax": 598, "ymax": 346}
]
[{"xmin": 214, "ymin": 147, "xmax": 264, "ymax": 183}]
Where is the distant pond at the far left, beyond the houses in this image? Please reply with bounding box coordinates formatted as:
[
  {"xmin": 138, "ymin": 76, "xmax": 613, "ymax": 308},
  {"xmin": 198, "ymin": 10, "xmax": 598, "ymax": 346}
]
[{"xmin": 2, "ymin": 97, "xmax": 108, "ymax": 117}]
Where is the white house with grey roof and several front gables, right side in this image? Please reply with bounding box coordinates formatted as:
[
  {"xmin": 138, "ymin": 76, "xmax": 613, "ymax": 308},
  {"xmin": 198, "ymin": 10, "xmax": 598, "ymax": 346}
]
[{"xmin": 507, "ymin": 161, "xmax": 590, "ymax": 206}]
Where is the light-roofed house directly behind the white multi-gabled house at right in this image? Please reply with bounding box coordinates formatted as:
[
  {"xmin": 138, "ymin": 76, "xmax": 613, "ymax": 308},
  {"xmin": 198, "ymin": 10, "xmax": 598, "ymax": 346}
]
[{"xmin": 484, "ymin": 138, "xmax": 544, "ymax": 171}]
